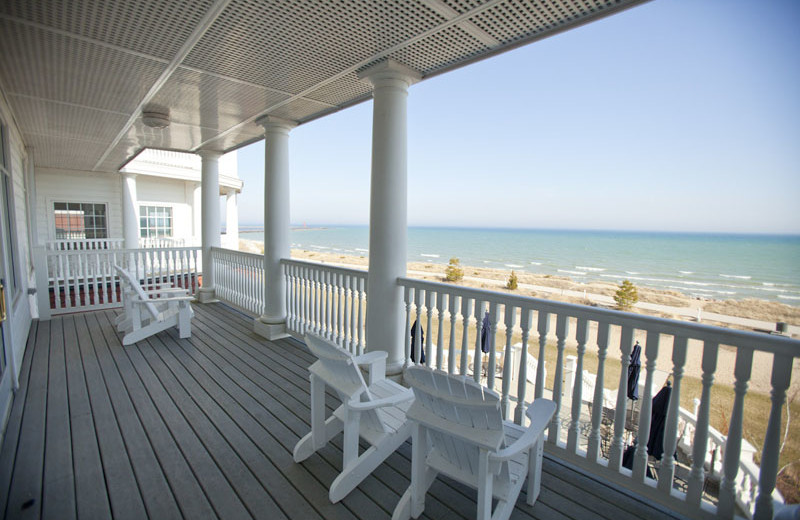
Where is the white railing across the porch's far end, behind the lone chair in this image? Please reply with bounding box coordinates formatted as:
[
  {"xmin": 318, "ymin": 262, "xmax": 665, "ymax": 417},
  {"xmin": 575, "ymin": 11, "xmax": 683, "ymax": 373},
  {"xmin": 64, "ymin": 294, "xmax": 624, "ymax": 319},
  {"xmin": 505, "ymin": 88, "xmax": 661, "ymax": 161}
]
[{"xmin": 35, "ymin": 247, "xmax": 201, "ymax": 317}]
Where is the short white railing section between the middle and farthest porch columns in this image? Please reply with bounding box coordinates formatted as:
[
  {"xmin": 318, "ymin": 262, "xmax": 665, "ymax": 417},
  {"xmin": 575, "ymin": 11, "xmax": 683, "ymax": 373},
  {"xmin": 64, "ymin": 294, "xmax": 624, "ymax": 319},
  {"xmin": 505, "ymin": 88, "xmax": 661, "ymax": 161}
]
[{"xmin": 211, "ymin": 247, "xmax": 265, "ymax": 317}]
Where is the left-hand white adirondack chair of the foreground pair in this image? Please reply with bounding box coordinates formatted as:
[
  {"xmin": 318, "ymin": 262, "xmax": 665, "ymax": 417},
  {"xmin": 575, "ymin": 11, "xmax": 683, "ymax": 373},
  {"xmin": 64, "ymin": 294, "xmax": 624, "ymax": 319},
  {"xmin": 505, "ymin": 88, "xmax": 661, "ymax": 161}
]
[{"xmin": 294, "ymin": 334, "xmax": 414, "ymax": 503}]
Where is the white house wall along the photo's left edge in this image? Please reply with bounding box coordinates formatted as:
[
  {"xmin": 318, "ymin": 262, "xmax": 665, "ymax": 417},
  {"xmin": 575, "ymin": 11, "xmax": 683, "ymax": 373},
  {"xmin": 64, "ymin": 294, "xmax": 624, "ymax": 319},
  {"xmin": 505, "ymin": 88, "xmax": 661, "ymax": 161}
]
[{"xmin": 0, "ymin": 91, "xmax": 35, "ymax": 432}]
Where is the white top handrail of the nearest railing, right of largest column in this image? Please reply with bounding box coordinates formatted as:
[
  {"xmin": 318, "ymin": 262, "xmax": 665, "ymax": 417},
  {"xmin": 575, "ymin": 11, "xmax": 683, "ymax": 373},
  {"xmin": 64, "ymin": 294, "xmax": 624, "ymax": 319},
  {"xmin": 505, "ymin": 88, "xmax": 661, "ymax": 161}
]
[{"xmin": 397, "ymin": 277, "xmax": 800, "ymax": 357}]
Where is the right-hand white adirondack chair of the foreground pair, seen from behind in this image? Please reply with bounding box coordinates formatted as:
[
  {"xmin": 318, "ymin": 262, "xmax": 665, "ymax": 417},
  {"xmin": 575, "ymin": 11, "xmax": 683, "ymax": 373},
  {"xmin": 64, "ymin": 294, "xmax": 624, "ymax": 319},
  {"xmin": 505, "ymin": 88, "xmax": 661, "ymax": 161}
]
[{"xmin": 392, "ymin": 367, "xmax": 556, "ymax": 520}]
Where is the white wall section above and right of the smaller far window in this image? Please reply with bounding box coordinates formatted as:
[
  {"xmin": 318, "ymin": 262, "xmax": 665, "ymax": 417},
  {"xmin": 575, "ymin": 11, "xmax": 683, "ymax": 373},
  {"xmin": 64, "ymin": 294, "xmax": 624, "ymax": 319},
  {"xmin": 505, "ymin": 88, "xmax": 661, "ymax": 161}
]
[{"xmin": 136, "ymin": 175, "xmax": 199, "ymax": 245}]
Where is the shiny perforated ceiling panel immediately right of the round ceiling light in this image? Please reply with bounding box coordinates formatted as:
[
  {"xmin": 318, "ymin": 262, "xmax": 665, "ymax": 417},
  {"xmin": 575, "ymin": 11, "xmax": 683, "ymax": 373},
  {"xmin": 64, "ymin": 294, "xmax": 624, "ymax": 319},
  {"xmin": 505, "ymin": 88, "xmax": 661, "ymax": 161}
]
[{"xmin": 152, "ymin": 68, "xmax": 289, "ymax": 131}]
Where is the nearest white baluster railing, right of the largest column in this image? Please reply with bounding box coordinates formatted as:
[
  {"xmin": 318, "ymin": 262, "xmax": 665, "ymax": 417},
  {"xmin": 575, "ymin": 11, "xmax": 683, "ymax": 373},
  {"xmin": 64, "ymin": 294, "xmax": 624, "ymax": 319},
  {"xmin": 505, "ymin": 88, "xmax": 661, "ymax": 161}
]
[{"xmin": 398, "ymin": 278, "xmax": 800, "ymax": 520}]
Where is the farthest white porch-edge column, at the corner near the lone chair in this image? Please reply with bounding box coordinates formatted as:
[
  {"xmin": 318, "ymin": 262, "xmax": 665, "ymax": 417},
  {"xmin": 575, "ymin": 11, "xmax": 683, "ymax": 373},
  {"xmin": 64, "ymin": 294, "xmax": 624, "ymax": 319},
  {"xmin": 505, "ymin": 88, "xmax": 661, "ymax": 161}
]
[{"xmin": 197, "ymin": 150, "xmax": 222, "ymax": 303}]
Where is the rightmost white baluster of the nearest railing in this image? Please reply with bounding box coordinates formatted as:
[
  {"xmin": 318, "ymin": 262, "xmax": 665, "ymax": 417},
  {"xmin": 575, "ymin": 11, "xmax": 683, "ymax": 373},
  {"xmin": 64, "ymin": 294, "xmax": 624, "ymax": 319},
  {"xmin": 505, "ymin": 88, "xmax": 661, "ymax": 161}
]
[{"xmin": 753, "ymin": 354, "xmax": 793, "ymax": 520}]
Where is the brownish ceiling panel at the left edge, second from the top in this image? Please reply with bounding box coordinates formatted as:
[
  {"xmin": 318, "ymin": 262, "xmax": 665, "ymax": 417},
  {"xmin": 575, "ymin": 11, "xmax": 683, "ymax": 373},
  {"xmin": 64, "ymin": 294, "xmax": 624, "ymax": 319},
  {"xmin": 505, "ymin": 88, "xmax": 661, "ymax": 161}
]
[{"xmin": 0, "ymin": 19, "xmax": 164, "ymax": 113}]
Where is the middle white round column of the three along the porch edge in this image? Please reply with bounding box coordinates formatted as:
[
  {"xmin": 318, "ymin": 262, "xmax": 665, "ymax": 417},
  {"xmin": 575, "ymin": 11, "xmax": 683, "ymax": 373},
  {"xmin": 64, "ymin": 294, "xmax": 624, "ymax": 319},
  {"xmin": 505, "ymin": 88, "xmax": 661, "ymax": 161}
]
[{"xmin": 253, "ymin": 116, "xmax": 296, "ymax": 339}]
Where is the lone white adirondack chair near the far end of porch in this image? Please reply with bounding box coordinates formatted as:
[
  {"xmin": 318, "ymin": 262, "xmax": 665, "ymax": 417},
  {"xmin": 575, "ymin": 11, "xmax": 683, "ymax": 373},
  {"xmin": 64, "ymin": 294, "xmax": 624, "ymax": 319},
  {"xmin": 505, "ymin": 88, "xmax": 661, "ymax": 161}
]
[{"xmin": 114, "ymin": 265, "xmax": 194, "ymax": 346}]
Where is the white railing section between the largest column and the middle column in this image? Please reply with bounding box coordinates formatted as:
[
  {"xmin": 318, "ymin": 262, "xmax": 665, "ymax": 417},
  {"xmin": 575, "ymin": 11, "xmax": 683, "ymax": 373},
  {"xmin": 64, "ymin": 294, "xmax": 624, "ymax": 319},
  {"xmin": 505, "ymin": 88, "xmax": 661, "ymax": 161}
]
[{"xmin": 281, "ymin": 259, "xmax": 367, "ymax": 355}]
